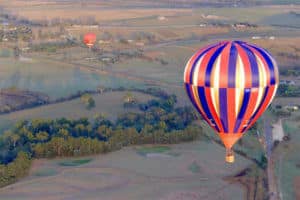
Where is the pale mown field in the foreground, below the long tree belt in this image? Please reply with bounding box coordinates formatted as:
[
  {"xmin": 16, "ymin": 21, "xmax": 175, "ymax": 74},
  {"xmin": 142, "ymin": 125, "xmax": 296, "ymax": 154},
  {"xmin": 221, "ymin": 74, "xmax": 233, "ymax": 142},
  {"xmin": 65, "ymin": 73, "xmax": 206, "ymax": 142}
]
[{"xmin": 0, "ymin": 141, "xmax": 250, "ymax": 200}]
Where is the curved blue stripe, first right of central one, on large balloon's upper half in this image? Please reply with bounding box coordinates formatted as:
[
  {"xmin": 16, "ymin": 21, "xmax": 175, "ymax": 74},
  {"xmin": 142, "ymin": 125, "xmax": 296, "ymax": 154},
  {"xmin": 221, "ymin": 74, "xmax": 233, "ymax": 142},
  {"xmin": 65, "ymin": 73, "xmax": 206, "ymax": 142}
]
[{"xmin": 241, "ymin": 44, "xmax": 259, "ymax": 87}]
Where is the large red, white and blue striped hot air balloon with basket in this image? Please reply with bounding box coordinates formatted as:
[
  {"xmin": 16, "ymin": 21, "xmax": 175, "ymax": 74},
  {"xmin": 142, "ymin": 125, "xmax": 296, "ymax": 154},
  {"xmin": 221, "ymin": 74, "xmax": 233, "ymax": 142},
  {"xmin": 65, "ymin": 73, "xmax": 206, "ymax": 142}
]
[{"xmin": 184, "ymin": 41, "xmax": 279, "ymax": 163}]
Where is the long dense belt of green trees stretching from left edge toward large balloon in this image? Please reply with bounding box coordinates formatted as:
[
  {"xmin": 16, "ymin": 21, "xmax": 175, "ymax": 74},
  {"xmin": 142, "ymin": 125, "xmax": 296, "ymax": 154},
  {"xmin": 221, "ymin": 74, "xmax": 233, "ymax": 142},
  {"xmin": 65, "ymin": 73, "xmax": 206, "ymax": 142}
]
[{"xmin": 0, "ymin": 89, "xmax": 202, "ymax": 188}]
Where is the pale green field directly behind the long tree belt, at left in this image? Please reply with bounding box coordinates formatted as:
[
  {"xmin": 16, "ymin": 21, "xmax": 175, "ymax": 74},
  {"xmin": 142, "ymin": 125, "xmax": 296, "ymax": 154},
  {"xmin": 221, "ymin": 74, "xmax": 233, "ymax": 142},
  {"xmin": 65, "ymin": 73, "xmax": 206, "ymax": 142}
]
[{"xmin": 0, "ymin": 92, "xmax": 153, "ymax": 130}]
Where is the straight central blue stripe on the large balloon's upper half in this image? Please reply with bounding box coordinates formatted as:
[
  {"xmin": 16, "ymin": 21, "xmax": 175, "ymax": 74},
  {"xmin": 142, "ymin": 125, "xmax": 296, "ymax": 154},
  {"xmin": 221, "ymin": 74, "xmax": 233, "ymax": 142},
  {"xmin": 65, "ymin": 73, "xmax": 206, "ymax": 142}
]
[{"xmin": 228, "ymin": 42, "xmax": 237, "ymax": 88}]
